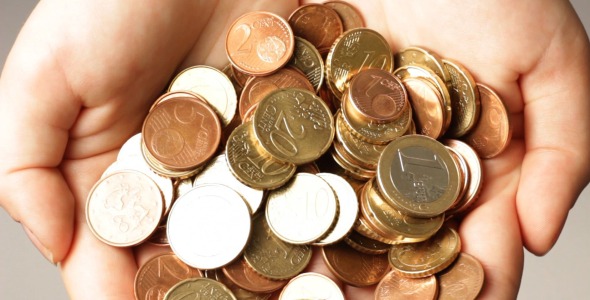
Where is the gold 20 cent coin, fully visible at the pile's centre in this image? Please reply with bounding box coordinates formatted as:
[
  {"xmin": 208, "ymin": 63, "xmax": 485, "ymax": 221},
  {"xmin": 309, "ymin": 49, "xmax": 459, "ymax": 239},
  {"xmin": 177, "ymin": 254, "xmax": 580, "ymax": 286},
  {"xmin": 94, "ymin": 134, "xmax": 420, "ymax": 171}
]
[{"xmin": 252, "ymin": 88, "xmax": 334, "ymax": 165}]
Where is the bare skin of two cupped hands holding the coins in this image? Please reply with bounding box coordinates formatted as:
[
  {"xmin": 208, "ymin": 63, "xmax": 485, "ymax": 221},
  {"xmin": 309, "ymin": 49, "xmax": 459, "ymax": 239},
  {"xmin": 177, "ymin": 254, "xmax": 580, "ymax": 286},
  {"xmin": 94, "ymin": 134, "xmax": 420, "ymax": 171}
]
[{"xmin": 0, "ymin": 0, "xmax": 590, "ymax": 299}]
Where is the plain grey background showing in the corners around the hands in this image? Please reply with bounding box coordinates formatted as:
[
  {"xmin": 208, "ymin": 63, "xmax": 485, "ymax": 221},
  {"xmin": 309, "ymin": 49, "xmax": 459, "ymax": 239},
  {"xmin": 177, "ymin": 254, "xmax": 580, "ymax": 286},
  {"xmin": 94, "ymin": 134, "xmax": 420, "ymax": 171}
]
[{"xmin": 0, "ymin": 0, "xmax": 590, "ymax": 299}]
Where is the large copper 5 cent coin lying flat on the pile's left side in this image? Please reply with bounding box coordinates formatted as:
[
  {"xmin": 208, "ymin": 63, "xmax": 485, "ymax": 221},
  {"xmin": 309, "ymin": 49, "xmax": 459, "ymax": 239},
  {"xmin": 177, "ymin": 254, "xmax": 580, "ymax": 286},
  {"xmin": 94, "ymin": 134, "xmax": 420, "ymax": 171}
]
[{"xmin": 142, "ymin": 97, "xmax": 221, "ymax": 170}]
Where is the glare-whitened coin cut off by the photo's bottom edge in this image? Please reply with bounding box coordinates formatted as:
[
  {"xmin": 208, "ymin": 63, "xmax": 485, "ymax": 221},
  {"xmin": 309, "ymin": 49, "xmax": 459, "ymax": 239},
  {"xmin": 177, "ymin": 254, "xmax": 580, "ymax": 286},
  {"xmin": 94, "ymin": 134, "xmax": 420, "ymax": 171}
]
[{"xmin": 279, "ymin": 272, "xmax": 344, "ymax": 300}]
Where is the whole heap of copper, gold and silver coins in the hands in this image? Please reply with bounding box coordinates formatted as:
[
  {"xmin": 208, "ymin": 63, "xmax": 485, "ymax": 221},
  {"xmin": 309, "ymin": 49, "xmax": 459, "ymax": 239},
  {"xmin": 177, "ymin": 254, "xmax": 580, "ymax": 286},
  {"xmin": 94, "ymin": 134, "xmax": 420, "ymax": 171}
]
[{"xmin": 86, "ymin": 1, "xmax": 510, "ymax": 299}]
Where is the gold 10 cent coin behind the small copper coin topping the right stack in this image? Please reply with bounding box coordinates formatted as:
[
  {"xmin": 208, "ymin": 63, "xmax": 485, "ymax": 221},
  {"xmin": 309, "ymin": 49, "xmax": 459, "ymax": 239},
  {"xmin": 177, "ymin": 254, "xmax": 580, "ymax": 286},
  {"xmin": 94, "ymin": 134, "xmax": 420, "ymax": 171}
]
[{"xmin": 326, "ymin": 28, "xmax": 393, "ymax": 98}]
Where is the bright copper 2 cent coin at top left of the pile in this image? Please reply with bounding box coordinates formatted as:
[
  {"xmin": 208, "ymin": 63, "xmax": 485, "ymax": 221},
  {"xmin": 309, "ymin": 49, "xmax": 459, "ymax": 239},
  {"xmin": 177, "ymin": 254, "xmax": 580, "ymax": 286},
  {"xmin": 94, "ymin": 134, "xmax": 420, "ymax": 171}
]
[{"xmin": 225, "ymin": 11, "xmax": 295, "ymax": 76}]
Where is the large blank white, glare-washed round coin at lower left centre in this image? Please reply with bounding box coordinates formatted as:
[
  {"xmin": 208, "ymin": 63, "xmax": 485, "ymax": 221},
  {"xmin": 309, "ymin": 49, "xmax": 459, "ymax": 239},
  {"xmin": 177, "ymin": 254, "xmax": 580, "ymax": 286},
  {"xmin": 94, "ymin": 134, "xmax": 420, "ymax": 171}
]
[{"xmin": 167, "ymin": 184, "xmax": 251, "ymax": 269}]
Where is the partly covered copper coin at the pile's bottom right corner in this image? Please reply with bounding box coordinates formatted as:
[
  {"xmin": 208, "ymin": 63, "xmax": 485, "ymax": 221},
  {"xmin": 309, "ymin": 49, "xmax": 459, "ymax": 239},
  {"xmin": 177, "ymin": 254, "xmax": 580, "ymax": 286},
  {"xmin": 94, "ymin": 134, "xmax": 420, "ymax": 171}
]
[{"xmin": 437, "ymin": 252, "xmax": 484, "ymax": 300}]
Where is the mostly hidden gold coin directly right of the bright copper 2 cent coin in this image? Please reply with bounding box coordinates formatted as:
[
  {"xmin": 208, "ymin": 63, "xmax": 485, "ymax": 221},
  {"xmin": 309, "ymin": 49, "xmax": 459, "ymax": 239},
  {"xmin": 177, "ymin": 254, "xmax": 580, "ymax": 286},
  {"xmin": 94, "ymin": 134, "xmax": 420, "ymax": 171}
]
[{"xmin": 288, "ymin": 36, "xmax": 324, "ymax": 93}]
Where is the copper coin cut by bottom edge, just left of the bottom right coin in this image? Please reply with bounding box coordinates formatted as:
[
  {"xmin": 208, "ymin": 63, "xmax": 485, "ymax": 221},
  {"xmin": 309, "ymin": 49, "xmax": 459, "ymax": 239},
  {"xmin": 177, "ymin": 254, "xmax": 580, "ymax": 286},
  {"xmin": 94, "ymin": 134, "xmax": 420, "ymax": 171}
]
[{"xmin": 375, "ymin": 271, "xmax": 438, "ymax": 300}]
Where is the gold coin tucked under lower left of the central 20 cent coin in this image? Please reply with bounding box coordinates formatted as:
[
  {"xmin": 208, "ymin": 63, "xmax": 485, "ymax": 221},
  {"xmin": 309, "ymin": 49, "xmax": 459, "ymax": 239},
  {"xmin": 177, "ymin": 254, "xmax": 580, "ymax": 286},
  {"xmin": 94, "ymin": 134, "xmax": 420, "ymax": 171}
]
[{"xmin": 225, "ymin": 122, "xmax": 297, "ymax": 189}]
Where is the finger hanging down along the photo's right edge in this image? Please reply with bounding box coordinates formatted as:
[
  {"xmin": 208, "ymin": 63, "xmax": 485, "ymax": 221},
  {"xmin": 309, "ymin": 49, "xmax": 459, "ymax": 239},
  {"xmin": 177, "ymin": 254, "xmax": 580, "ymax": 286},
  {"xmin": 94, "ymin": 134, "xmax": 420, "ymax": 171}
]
[{"xmin": 517, "ymin": 1, "xmax": 590, "ymax": 255}]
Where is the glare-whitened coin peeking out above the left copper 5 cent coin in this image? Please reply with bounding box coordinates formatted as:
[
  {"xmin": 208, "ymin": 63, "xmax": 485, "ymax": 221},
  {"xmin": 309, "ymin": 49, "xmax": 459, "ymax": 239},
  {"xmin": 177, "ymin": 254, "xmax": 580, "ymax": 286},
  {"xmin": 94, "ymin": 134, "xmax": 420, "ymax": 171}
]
[{"xmin": 168, "ymin": 66, "xmax": 238, "ymax": 126}]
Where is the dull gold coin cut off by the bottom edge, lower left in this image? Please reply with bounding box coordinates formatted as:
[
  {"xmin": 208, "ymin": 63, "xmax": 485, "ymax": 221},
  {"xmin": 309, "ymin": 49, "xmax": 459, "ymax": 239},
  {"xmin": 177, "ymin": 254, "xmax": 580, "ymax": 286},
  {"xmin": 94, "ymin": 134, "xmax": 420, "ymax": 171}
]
[{"xmin": 164, "ymin": 278, "xmax": 238, "ymax": 300}]
